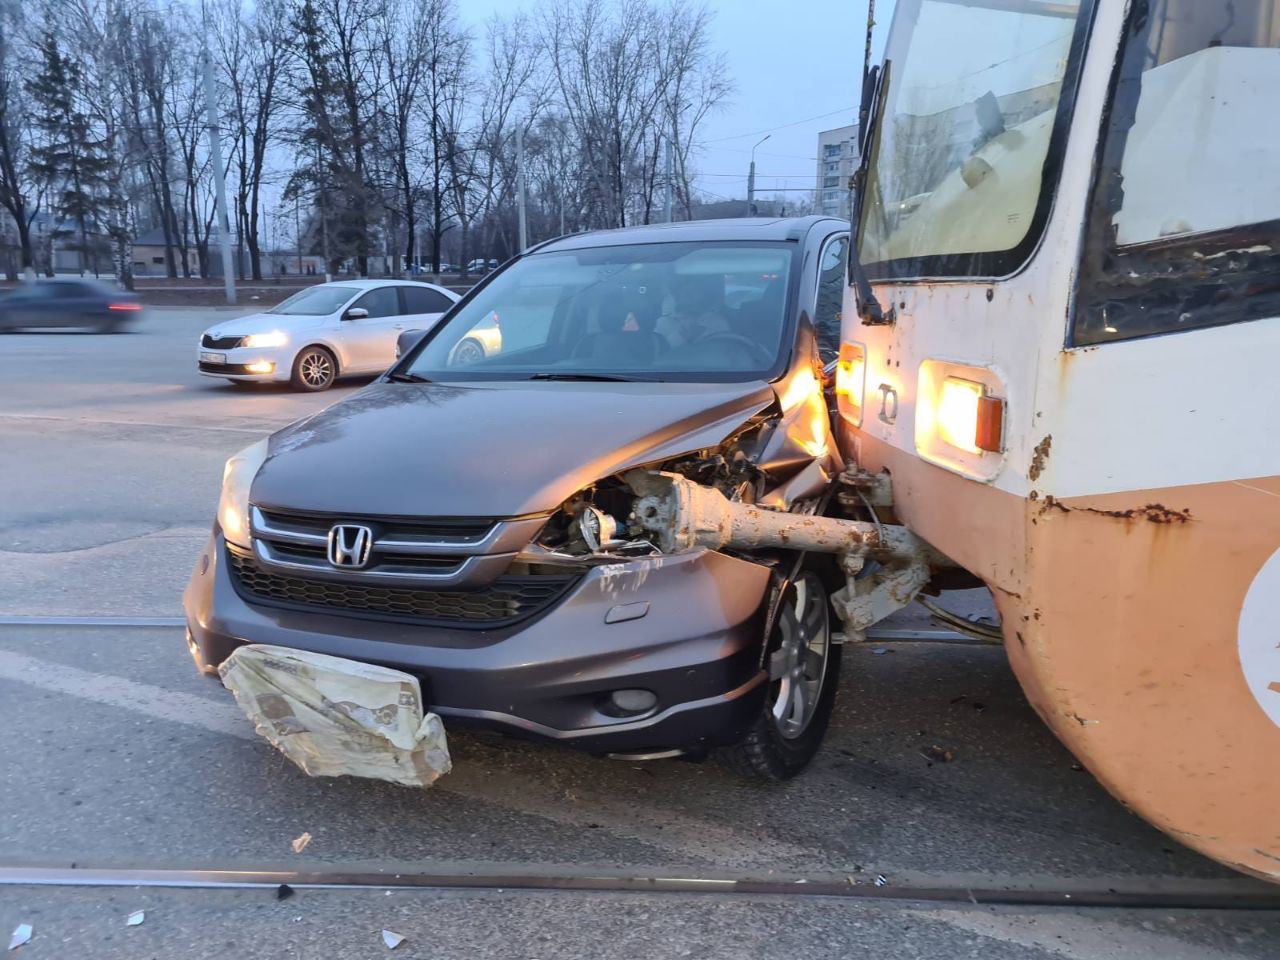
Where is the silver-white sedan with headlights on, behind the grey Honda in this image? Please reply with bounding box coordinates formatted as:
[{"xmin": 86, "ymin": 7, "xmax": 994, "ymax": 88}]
[{"xmin": 198, "ymin": 280, "xmax": 460, "ymax": 390}]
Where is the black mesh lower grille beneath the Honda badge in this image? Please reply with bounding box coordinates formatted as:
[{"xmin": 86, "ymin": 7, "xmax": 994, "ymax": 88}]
[{"xmin": 227, "ymin": 547, "xmax": 577, "ymax": 628}]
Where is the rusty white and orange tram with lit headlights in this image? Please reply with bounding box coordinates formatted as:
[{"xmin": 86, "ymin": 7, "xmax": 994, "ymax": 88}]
[{"xmin": 838, "ymin": 0, "xmax": 1280, "ymax": 879}]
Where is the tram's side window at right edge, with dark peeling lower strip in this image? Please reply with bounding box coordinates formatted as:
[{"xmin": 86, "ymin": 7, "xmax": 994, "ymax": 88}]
[{"xmin": 1073, "ymin": 0, "xmax": 1280, "ymax": 344}]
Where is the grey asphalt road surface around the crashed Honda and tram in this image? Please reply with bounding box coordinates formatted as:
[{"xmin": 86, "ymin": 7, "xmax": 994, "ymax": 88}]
[{"xmin": 0, "ymin": 310, "xmax": 1280, "ymax": 960}]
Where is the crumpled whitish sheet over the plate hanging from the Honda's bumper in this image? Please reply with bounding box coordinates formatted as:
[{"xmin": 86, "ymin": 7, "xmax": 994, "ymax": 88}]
[{"xmin": 218, "ymin": 644, "xmax": 452, "ymax": 788}]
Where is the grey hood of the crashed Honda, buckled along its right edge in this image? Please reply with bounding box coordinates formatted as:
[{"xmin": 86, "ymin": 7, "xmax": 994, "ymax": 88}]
[{"xmin": 251, "ymin": 381, "xmax": 774, "ymax": 517}]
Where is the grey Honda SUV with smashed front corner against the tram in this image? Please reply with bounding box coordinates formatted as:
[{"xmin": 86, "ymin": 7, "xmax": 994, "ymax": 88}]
[{"xmin": 183, "ymin": 216, "xmax": 849, "ymax": 780}]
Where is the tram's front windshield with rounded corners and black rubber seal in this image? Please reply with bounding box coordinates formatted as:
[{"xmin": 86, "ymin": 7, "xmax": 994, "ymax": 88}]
[{"xmin": 859, "ymin": 0, "xmax": 1091, "ymax": 278}]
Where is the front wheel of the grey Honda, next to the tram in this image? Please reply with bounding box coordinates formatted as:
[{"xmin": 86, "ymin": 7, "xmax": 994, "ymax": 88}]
[{"xmin": 716, "ymin": 568, "xmax": 841, "ymax": 782}]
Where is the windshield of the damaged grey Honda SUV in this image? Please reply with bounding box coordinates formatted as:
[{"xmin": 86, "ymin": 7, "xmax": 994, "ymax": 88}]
[{"xmin": 398, "ymin": 242, "xmax": 795, "ymax": 381}]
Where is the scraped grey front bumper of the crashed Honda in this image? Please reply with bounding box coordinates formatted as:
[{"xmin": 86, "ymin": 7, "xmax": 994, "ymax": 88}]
[{"xmin": 183, "ymin": 531, "xmax": 771, "ymax": 753}]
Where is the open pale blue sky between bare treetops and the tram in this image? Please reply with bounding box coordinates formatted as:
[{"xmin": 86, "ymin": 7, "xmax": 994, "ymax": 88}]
[{"xmin": 458, "ymin": 0, "xmax": 892, "ymax": 198}]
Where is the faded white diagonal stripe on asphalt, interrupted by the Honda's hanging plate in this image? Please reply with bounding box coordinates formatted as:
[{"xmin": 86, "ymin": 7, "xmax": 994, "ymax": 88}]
[{"xmin": 0, "ymin": 650, "xmax": 820, "ymax": 865}]
